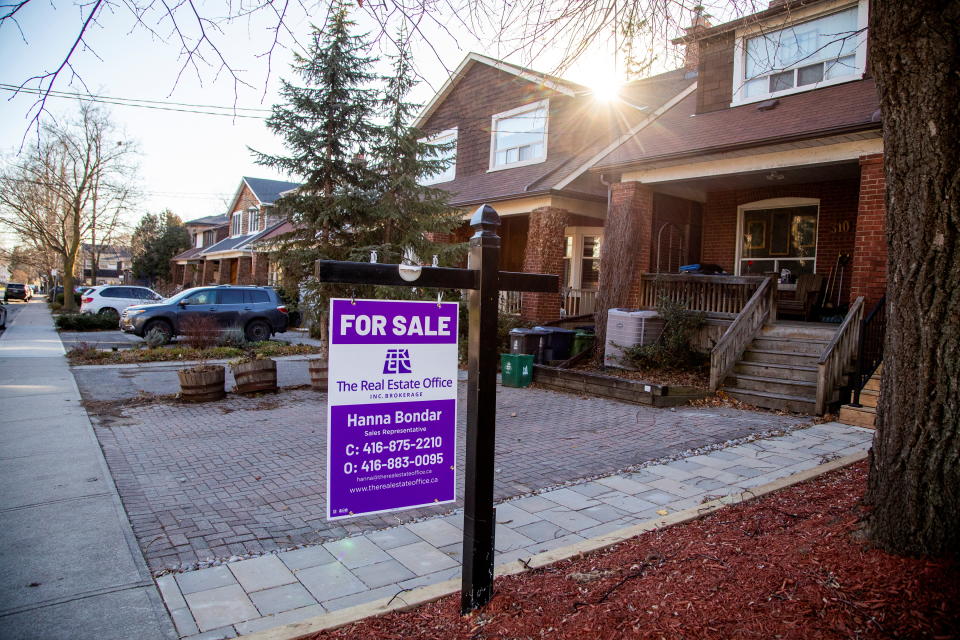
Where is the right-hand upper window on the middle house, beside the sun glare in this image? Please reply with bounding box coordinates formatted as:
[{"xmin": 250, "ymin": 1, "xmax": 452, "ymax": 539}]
[{"xmin": 490, "ymin": 100, "xmax": 550, "ymax": 171}]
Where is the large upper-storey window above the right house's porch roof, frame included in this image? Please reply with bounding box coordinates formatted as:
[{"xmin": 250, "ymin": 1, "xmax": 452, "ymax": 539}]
[{"xmin": 733, "ymin": 2, "xmax": 866, "ymax": 105}]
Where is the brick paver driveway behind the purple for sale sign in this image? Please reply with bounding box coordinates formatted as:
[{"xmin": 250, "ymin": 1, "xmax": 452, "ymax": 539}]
[{"xmin": 96, "ymin": 385, "xmax": 809, "ymax": 569}]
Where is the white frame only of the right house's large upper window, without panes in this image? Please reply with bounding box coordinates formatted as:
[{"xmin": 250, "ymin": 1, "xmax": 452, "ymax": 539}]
[{"xmin": 730, "ymin": 0, "xmax": 869, "ymax": 107}]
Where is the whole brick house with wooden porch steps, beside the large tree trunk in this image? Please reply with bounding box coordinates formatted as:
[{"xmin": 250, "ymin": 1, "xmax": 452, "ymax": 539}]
[{"xmin": 591, "ymin": 0, "xmax": 886, "ymax": 413}]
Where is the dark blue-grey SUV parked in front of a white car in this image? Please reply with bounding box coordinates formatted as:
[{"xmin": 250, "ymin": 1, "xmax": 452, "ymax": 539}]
[{"xmin": 120, "ymin": 285, "xmax": 289, "ymax": 342}]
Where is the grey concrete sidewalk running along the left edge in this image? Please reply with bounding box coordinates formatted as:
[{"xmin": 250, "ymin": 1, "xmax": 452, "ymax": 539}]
[{"xmin": 0, "ymin": 301, "xmax": 176, "ymax": 640}]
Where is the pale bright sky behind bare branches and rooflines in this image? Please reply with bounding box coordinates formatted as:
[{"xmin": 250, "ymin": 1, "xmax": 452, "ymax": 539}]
[{"xmin": 0, "ymin": 0, "xmax": 704, "ymax": 245}]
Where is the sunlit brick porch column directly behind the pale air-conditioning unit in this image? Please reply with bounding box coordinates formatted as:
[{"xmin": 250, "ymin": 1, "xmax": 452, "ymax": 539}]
[{"xmin": 594, "ymin": 182, "xmax": 653, "ymax": 348}]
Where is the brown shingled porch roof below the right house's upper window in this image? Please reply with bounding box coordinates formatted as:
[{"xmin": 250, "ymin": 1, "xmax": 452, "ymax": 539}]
[{"xmin": 594, "ymin": 78, "xmax": 880, "ymax": 171}]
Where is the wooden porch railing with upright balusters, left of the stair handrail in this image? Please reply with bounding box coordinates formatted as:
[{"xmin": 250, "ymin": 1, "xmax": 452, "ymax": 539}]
[{"xmin": 640, "ymin": 273, "xmax": 776, "ymax": 318}]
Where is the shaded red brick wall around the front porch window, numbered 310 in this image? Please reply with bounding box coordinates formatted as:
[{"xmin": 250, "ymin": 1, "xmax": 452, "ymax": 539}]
[{"xmin": 700, "ymin": 180, "xmax": 859, "ymax": 304}]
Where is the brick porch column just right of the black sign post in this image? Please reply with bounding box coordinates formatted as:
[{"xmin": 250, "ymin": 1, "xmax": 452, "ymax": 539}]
[{"xmin": 520, "ymin": 207, "xmax": 570, "ymax": 322}]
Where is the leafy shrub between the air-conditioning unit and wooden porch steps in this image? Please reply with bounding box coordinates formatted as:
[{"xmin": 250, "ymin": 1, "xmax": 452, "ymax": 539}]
[{"xmin": 624, "ymin": 296, "xmax": 707, "ymax": 371}]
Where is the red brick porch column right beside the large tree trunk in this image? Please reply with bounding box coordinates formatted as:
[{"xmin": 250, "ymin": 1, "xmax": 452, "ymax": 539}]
[{"xmin": 850, "ymin": 153, "xmax": 887, "ymax": 313}]
